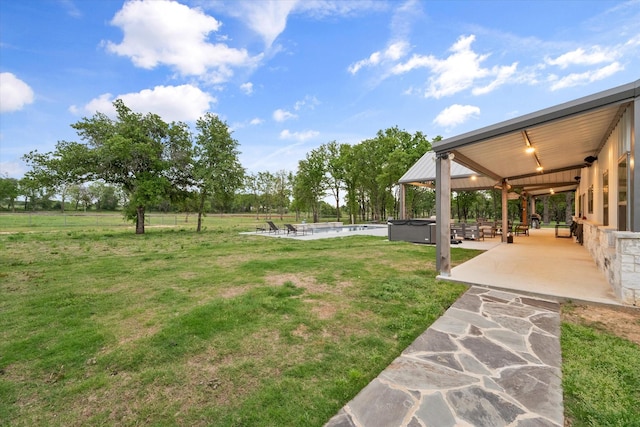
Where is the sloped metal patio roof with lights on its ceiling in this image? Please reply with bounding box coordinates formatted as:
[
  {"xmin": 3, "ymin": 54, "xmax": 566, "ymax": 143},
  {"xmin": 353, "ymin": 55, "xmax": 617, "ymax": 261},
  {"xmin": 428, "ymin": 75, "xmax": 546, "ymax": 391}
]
[{"xmin": 399, "ymin": 80, "xmax": 640, "ymax": 195}]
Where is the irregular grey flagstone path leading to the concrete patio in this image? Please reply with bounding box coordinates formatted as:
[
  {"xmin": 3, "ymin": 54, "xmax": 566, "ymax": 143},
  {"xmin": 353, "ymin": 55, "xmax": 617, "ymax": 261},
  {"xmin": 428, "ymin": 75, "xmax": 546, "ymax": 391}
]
[{"xmin": 325, "ymin": 287, "xmax": 564, "ymax": 427}]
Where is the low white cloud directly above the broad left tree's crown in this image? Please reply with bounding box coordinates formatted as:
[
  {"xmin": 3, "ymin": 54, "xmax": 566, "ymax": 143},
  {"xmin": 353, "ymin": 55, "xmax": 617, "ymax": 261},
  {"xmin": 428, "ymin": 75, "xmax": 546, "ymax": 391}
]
[{"xmin": 74, "ymin": 85, "xmax": 217, "ymax": 122}]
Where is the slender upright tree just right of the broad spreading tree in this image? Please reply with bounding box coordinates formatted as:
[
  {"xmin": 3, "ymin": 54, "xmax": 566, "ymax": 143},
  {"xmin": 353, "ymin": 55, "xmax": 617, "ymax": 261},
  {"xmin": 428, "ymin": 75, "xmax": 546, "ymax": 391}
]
[{"xmin": 193, "ymin": 113, "xmax": 244, "ymax": 232}]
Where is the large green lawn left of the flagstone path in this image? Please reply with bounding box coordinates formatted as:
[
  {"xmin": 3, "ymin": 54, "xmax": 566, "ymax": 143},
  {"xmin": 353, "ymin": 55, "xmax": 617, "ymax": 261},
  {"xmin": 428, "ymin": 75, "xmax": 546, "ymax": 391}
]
[{"xmin": 0, "ymin": 217, "xmax": 470, "ymax": 426}]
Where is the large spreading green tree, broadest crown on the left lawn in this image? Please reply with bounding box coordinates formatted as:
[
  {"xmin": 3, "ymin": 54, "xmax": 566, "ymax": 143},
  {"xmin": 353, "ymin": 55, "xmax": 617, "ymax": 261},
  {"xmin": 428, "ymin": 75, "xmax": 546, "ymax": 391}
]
[{"xmin": 69, "ymin": 99, "xmax": 191, "ymax": 234}]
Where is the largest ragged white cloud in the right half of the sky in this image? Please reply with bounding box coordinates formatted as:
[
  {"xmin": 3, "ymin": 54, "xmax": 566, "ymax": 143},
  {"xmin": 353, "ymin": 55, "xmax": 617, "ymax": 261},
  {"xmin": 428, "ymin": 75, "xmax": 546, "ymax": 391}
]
[{"xmin": 391, "ymin": 35, "xmax": 518, "ymax": 98}]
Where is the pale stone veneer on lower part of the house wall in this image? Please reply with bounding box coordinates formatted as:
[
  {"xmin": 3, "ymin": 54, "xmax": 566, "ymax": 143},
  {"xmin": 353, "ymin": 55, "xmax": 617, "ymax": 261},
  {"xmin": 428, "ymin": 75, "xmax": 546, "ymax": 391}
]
[{"xmin": 582, "ymin": 221, "xmax": 640, "ymax": 306}]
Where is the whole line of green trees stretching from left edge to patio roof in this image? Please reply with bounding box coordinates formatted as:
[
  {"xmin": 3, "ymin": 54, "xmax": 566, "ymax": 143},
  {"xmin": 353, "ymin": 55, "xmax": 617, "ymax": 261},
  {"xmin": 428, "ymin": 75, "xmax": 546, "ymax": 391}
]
[{"xmin": 0, "ymin": 100, "xmax": 439, "ymax": 234}]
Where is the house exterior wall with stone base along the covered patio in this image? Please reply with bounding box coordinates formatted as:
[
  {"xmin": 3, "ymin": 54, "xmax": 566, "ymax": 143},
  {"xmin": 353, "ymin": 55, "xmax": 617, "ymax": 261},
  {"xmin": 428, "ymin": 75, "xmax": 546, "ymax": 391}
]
[{"xmin": 576, "ymin": 105, "xmax": 640, "ymax": 305}]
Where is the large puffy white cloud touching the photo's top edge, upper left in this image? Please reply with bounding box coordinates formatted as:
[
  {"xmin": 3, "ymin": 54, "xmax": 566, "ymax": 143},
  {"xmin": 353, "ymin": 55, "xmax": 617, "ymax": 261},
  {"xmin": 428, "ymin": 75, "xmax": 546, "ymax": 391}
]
[{"xmin": 106, "ymin": 0, "xmax": 261, "ymax": 83}]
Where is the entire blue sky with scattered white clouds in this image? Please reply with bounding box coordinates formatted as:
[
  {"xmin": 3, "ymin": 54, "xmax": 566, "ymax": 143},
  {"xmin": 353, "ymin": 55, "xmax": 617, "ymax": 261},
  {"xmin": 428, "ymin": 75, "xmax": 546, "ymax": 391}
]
[{"xmin": 0, "ymin": 0, "xmax": 640, "ymax": 178}]
